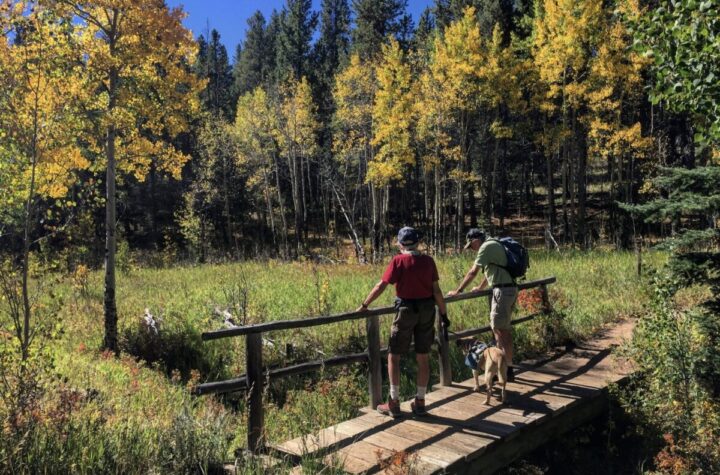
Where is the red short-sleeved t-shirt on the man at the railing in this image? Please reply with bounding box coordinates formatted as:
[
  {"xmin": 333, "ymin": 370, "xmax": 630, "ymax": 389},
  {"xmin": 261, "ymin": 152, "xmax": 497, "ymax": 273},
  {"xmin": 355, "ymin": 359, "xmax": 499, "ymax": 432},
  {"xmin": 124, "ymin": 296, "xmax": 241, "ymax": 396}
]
[{"xmin": 382, "ymin": 254, "xmax": 440, "ymax": 299}]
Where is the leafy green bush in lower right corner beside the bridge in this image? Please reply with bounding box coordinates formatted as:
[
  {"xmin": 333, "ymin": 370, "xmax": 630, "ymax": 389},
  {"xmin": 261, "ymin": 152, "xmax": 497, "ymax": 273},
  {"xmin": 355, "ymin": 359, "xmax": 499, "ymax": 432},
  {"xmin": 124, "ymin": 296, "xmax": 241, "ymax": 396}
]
[{"xmin": 619, "ymin": 274, "xmax": 720, "ymax": 473}]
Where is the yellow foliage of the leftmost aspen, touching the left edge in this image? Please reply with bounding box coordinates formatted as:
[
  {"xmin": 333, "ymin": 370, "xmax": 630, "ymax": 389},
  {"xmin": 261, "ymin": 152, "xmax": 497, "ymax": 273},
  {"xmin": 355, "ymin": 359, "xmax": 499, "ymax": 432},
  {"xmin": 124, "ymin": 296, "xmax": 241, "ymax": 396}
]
[{"xmin": 0, "ymin": 1, "xmax": 89, "ymax": 207}]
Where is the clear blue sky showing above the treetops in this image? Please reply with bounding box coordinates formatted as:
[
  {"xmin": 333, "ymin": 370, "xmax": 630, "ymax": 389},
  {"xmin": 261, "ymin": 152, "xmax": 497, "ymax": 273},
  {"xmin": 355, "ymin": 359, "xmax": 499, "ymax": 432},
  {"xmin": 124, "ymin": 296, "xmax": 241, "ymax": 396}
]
[{"xmin": 167, "ymin": 0, "xmax": 434, "ymax": 57}]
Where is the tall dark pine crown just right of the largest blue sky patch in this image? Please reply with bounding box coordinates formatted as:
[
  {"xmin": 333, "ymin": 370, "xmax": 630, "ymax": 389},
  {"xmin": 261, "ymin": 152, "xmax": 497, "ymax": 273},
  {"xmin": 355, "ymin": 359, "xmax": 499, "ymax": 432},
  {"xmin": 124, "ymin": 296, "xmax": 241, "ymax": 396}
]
[{"xmin": 275, "ymin": 0, "xmax": 318, "ymax": 80}]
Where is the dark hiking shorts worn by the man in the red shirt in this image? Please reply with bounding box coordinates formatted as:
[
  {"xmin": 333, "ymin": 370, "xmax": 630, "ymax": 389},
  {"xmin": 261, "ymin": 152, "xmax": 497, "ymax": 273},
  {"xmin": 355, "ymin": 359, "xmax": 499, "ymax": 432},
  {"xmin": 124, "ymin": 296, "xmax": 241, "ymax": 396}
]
[{"xmin": 388, "ymin": 298, "xmax": 435, "ymax": 355}]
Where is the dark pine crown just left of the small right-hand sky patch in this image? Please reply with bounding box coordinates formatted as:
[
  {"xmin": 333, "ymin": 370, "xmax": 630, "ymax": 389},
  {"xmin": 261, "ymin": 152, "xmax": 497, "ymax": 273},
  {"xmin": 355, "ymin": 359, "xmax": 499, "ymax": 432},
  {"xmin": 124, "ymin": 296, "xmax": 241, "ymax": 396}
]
[{"xmin": 352, "ymin": 0, "xmax": 407, "ymax": 59}]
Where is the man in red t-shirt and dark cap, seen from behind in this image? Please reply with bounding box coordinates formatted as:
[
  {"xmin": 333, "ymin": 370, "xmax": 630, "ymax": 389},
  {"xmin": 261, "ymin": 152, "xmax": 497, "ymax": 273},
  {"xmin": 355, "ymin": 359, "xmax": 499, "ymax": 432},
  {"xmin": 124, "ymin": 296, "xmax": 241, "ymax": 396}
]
[{"xmin": 358, "ymin": 227, "xmax": 447, "ymax": 417}]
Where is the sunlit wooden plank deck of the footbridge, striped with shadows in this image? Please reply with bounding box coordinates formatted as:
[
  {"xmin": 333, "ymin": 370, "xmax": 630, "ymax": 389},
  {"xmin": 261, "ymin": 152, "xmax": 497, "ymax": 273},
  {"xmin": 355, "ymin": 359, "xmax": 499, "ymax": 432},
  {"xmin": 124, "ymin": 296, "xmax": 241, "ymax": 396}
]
[{"xmin": 275, "ymin": 321, "xmax": 634, "ymax": 474}]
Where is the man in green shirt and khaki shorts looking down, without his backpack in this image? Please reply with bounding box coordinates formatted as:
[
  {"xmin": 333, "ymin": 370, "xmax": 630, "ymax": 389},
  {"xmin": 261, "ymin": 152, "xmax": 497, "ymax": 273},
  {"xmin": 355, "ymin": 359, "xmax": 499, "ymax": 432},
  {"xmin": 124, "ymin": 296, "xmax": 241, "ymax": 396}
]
[{"xmin": 448, "ymin": 228, "xmax": 518, "ymax": 381}]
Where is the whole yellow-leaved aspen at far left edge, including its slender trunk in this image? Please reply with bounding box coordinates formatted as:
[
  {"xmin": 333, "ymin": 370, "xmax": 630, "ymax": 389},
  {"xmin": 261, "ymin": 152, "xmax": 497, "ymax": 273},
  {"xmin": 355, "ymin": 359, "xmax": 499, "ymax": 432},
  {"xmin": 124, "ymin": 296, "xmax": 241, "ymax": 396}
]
[{"xmin": 0, "ymin": 1, "xmax": 89, "ymax": 364}]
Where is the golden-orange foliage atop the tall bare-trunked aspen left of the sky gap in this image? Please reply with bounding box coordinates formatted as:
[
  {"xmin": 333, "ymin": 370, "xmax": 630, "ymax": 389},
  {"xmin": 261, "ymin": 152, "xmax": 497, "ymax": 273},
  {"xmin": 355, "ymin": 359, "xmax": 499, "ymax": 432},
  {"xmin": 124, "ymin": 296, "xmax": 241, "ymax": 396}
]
[{"xmin": 69, "ymin": 0, "xmax": 204, "ymax": 180}]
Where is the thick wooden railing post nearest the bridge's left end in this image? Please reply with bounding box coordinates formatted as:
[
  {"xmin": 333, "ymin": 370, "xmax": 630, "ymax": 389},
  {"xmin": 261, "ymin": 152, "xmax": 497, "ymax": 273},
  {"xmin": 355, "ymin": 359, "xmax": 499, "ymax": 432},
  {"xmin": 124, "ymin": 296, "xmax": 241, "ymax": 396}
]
[{"xmin": 245, "ymin": 333, "xmax": 265, "ymax": 453}]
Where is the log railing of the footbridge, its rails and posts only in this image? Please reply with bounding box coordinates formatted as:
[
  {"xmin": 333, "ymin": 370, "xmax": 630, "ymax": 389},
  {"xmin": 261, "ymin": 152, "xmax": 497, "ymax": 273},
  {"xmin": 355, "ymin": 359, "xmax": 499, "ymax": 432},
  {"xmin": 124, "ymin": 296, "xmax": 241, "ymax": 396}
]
[{"xmin": 195, "ymin": 277, "xmax": 556, "ymax": 452}]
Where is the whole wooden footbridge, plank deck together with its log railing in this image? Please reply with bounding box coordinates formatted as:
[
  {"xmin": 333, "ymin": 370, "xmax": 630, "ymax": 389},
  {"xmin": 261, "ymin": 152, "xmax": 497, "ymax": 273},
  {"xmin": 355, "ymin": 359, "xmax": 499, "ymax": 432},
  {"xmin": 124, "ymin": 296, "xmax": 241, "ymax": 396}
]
[{"xmin": 196, "ymin": 277, "xmax": 632, "ymax": 474}]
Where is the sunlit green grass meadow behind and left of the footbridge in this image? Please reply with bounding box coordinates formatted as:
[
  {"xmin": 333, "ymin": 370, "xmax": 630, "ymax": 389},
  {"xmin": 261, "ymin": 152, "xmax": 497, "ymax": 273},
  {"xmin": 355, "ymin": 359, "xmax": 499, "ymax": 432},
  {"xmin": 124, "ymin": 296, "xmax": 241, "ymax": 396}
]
[{"xmin": 0, "ymin": 251, "xmax": 665, "ymax": 473}]
